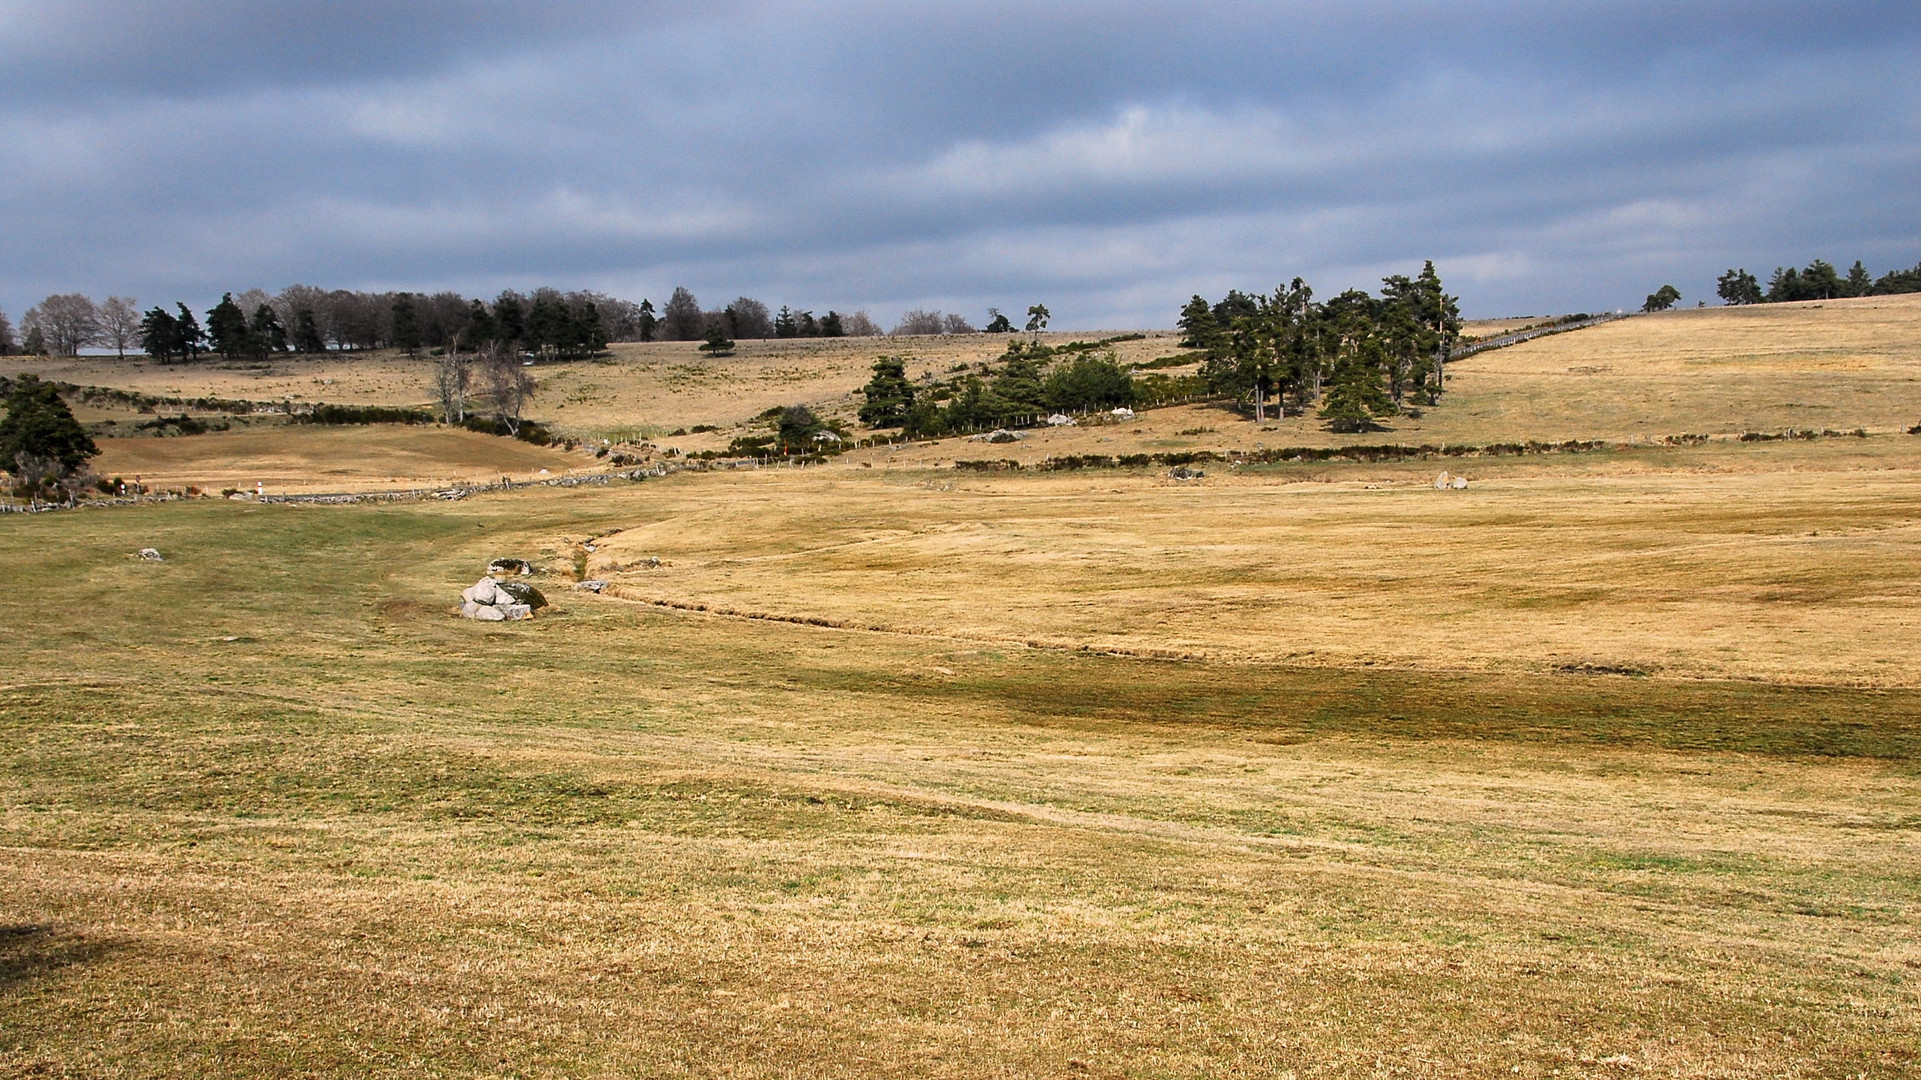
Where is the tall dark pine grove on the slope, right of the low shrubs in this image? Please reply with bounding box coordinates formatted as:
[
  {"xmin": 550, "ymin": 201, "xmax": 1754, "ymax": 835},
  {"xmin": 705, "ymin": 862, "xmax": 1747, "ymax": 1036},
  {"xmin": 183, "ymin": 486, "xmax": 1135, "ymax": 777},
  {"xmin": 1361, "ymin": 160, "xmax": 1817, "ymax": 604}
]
[{"xmin": 1179, "ymin": 261, "xmax": 1460, "ymax": 430}]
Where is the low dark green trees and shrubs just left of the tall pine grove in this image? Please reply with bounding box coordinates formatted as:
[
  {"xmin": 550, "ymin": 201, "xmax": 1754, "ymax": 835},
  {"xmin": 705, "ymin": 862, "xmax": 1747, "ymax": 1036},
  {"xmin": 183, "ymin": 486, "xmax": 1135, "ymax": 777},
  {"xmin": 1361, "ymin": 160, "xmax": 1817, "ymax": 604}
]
[{"xmin": 861, "ymin": 340, "xmax": 1137, "ymax": 436}]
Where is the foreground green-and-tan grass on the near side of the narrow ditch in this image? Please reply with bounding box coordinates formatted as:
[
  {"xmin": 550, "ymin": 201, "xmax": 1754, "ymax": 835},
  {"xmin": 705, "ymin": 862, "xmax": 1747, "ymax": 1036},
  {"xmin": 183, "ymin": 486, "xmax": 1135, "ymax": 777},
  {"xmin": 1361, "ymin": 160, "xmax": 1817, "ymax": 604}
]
[{"xmin": 0, "ymin": 477, "xmax": 1921, "ymax": 1078}]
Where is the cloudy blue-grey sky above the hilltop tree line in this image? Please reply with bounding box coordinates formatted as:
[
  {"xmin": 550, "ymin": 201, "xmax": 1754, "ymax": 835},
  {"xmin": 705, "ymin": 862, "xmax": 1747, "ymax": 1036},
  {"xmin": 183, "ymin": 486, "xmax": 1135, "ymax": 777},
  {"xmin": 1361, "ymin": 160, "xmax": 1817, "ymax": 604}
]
[{"xmin": 0, "ymin": 0, "xmax": 1921, "ymax": 329}]
